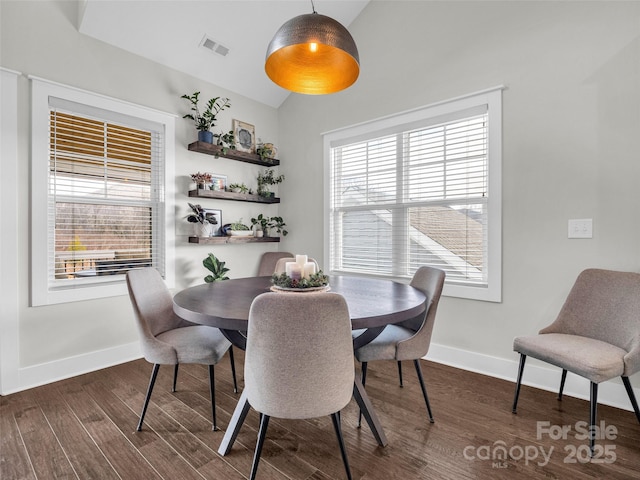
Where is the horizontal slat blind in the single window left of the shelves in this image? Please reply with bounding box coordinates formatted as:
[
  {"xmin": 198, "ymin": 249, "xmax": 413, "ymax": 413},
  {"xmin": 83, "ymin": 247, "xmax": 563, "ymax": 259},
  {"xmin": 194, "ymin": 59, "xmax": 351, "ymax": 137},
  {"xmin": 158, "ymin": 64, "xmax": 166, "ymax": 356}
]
[{"xmin": 47, "ymin": 107, "xmax": 164, "ymax": 288}]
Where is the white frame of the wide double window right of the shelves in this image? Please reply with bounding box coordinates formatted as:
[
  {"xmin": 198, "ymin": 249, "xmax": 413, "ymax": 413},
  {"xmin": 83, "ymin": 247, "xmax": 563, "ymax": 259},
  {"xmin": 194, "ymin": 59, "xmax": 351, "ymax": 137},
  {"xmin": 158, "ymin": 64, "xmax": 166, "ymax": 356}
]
[{"xmin": 323, "ymin": 86, "xmax": 504, "ymax": 302}]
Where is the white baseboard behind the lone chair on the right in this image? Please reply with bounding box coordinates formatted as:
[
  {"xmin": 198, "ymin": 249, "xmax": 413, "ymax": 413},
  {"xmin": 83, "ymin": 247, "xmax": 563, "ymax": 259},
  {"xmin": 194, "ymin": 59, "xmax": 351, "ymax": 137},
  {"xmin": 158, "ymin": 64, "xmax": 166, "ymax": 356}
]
[{"xmin": 426, "ymin": 343, "xmax": 640, "ymax": 411}]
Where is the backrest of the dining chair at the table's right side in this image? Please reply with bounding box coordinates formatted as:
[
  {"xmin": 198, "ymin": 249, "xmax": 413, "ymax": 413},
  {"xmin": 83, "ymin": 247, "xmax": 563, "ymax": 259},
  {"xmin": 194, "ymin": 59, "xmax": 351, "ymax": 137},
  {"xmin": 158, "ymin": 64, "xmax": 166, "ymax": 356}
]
[{"xmin": 397, "ymin": 267, "xmax": 445, "ymax": 360}]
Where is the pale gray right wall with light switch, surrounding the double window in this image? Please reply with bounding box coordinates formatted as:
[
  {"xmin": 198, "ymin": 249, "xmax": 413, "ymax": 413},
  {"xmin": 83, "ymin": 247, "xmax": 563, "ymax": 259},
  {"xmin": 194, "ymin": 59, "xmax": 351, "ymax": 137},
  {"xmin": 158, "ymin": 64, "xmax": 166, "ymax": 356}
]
[{"xmin": 279, "ymin": 1, "xmax": 640, "ymax": 408}]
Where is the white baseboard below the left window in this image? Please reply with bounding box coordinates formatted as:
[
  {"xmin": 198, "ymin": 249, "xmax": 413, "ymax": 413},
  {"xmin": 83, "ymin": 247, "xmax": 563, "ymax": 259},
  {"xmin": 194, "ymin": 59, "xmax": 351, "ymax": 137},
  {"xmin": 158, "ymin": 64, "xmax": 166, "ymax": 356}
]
[{"xmin": 2, "ymin": 342, "xmax": 142, "ymax": 395}]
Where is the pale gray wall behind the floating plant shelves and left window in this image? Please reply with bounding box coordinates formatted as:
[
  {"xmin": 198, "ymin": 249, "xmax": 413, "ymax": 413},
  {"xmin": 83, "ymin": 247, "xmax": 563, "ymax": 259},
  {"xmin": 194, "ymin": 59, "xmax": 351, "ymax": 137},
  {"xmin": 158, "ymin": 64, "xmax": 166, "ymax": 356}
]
[{"xmin": 0, "ymin": 1, "xmax": 279, "ymax": 393}]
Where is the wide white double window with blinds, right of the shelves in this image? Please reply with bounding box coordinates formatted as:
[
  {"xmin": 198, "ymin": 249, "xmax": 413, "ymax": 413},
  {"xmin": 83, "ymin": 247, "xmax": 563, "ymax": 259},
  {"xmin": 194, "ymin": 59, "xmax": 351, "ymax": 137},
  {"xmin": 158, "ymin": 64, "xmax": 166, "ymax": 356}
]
[{"xmin": 325, "ymin": 89, "xmax": 501, "ymax": 301}]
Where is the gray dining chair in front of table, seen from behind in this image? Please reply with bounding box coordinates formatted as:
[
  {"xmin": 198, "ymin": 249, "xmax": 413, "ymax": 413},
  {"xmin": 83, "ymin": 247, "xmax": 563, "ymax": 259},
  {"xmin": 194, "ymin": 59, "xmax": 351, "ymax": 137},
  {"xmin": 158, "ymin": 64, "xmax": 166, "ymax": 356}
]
[{"xmin": 244, "ymin": 292, "xmax": 355, "ymax": 479}]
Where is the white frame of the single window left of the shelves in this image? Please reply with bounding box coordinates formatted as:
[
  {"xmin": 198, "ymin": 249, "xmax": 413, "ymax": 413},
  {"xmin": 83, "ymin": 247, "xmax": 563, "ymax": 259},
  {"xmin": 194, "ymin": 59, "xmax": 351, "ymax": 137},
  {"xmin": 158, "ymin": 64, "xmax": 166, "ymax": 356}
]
[{"xmin": 29, "ymin": 76, "xmax": 176, "ymax": 306}]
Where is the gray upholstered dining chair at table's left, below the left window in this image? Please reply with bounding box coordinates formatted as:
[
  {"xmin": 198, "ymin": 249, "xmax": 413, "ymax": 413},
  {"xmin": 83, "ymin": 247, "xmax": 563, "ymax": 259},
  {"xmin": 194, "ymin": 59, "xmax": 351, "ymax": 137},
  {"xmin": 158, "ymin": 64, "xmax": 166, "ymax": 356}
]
[{"xmin": 127, "ymin": 267, "xmax": 238, "ymax": 431}]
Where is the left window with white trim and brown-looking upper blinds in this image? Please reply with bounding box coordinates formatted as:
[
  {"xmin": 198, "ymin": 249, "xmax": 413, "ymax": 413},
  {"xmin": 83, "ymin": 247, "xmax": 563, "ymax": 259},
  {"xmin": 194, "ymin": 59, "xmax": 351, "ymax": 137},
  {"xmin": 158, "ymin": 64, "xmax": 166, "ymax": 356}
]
[{"xmin": 32, "ymin": 80, "xmax": 173, "ymax": 305}]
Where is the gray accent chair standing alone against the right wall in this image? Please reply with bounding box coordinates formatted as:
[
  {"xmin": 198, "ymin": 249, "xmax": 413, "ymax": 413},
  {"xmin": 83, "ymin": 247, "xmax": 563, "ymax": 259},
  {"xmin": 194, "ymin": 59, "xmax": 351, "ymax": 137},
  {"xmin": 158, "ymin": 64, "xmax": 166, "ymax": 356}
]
[{"xmin": 512, "ymin": 269, "xmax": 640, "ymax": 455}]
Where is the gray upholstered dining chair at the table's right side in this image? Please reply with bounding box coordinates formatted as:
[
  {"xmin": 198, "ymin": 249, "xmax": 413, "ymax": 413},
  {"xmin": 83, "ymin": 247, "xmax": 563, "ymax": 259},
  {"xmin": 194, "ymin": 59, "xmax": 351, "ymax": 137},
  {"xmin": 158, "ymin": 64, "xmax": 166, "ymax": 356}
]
[{"xmin": 353, "ymin": 267, "xmax": 445, "ymax": 426}]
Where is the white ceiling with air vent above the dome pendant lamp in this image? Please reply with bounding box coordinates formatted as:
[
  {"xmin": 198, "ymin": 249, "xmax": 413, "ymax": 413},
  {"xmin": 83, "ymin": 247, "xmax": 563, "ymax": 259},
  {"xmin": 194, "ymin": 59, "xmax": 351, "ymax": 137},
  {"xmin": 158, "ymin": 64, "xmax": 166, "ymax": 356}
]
[{"xmin": 79, "ymin": 0, "xmax": 369, "ymax": 108}]
